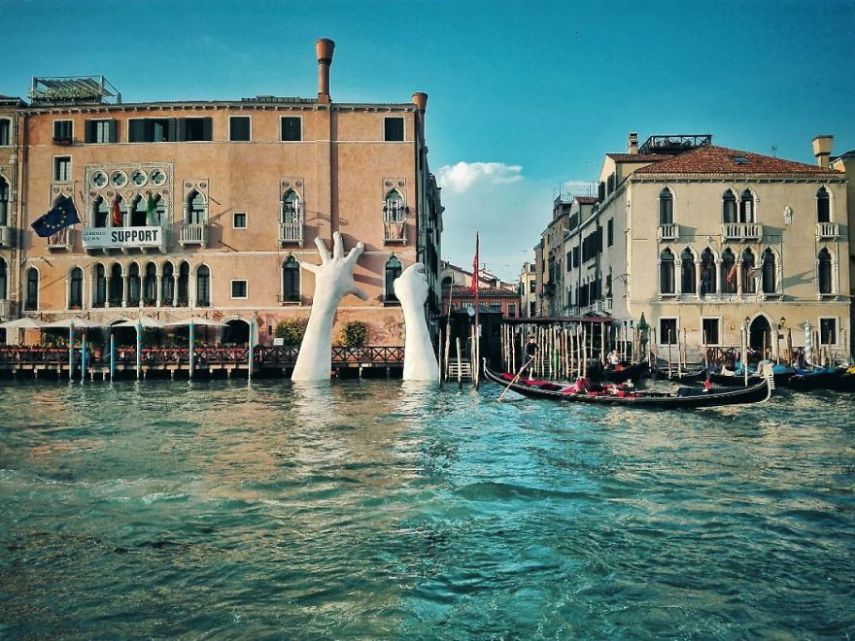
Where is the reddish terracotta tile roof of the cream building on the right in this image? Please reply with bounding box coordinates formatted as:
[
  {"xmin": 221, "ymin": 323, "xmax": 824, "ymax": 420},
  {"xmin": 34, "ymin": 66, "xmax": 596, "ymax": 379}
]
[{"xmin": 635, "ymin": 145, "xmax": 842, "ymax": 174}]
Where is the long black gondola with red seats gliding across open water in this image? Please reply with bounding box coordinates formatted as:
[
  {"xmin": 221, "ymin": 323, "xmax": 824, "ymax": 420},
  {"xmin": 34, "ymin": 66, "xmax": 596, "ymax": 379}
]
[{"xmin": 484, "ymin": 362, "xmax": 771, "ymax": 409}]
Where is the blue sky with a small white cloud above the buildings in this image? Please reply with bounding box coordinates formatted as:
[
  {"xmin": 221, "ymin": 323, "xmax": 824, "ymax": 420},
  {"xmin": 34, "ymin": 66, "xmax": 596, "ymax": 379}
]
[{"xmin": 0, "ymin": 0, "xmax": 855, "ymax": 278}]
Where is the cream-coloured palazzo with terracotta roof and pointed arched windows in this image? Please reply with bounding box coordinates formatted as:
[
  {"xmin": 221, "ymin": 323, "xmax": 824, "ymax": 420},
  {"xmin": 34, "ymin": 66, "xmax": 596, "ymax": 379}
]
[{"xmin": 568, "ymin": 134, "xmax": 851, "ymax": 360}]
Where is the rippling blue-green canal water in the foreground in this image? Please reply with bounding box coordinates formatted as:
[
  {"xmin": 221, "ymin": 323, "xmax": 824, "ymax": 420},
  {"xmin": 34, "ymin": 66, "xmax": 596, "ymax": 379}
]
[{"xmin": 0, "ymin": 380, "xmax": 855, "ymax": 641}]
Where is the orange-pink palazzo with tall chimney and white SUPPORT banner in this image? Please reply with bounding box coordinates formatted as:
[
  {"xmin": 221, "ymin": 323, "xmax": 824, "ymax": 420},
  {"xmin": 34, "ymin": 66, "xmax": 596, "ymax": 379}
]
[{"xmin": 0, "ymin": 40, "xmax": 443, "ymax": 344}]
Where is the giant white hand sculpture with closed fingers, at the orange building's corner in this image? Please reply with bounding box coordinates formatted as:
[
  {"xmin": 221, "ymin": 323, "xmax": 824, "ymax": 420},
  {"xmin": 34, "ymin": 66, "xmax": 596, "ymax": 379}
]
[{"xmin": 392, "ymin": 263, "xmax": 439, "ymax": 381}]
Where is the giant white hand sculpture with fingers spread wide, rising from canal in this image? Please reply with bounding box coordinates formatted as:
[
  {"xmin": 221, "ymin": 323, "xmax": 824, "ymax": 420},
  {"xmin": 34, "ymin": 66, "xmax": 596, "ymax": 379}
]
[{"xmin": 291, "ymin": 232, "xmax": 368, "ymax": 381}]
